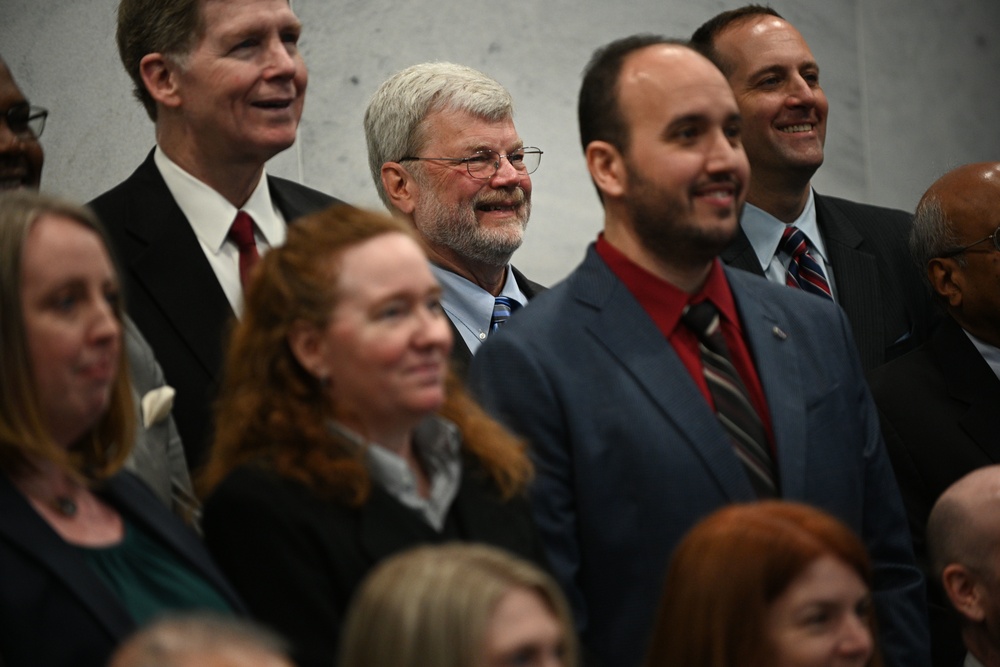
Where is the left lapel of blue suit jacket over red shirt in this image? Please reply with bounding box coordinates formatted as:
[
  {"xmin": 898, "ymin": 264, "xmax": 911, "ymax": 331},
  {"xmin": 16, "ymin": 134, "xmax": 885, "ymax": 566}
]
[{"xmin": 572, "ymin": 247, "xmax": 755, "ymax": 501}]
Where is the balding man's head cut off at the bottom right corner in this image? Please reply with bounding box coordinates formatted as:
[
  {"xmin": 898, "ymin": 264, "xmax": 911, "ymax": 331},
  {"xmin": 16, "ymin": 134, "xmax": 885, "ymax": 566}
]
[{"xmin": 927, "ymin": 465, "xmax": 1000, "ymax": 667}]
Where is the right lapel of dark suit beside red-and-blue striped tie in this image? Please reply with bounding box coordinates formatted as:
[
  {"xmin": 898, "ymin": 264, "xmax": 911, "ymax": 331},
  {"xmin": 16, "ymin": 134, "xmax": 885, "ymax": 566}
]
[{"xmin": 815, "ymin": 194, "xmax": 891, "ymax": 368}]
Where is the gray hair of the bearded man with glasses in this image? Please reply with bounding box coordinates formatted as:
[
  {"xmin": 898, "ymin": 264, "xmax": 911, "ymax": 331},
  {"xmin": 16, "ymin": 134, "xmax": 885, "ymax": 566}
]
[{"xmin": 365, "ymin": 63, "xmax": 514, "ymax": 209}]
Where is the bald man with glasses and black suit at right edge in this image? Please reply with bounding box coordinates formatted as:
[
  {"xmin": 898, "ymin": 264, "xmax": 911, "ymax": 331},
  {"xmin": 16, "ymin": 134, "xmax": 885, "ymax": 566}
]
[{"xmin": 870, "ymin": 163, "xmax": 1000, "ymax": 665}]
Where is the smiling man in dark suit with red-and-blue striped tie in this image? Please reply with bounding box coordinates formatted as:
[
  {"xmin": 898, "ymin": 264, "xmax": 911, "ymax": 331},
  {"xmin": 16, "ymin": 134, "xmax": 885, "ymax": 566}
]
[{"xmin": 692, "ymin": 5, "xmax": 933, "ymax": 370}]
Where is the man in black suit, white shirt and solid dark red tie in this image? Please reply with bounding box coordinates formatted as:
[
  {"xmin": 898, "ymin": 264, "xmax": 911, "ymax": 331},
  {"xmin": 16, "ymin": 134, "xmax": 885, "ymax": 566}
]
[{"xmin": 91, "ymin": 0, "xmax": 335, "ymax": 466}]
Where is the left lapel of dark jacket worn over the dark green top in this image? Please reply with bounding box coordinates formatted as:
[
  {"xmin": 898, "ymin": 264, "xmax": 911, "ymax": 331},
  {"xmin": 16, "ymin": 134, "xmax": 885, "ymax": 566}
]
[{"xmin": 0, "ymin": 473, "xmax": 135, "ymax": 640}]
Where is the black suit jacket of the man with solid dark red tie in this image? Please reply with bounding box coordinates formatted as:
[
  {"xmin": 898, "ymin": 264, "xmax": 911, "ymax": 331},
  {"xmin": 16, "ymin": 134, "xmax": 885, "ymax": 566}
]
[{"xmin": 90, "ymin": 151, "xmax": 338, "ymax": 468}]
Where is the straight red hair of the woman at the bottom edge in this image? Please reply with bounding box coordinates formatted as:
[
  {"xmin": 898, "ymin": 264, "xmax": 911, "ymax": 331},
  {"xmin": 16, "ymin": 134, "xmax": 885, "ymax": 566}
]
[{"xmin": 646, "ymin": 501, "xmax": 882, "ymax": 667}]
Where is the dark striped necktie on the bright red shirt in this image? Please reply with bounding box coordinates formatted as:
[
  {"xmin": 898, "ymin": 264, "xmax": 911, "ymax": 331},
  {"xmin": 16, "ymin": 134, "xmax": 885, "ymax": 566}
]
[{"xmin": 681, "ymin": 301, "xmax": 779, "ymax": 498}]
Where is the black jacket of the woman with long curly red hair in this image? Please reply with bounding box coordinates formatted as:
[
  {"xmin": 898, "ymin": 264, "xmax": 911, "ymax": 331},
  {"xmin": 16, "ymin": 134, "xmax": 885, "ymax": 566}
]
[{"xmin": 203, "ymin": 456, "xmax": 546, "ymax": 667}]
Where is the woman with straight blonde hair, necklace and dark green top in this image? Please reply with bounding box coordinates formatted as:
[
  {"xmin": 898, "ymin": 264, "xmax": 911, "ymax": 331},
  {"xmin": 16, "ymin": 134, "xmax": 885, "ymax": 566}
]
[{"xmin": 0, "ymin": 192, "xmax": 242, "ymax": 667}]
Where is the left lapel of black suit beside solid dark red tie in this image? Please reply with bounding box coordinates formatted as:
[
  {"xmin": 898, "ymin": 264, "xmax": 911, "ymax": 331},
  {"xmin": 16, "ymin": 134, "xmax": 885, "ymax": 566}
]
[{"xmin": 117, "ymin": 153, "xmax": 233, "ymax": 384}]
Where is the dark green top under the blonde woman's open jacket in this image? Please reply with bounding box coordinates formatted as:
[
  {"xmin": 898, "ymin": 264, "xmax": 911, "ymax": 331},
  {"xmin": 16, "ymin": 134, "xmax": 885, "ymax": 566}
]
[{"xmin": 77, "ymin": 517, "xmax": 233, "ymax": 626}]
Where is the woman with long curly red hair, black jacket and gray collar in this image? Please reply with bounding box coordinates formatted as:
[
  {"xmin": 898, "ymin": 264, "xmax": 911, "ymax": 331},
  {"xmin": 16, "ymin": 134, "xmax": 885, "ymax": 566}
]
[{"xmin": 202, "ymin": 206, "xmax": 544, "ymax": 667}]
